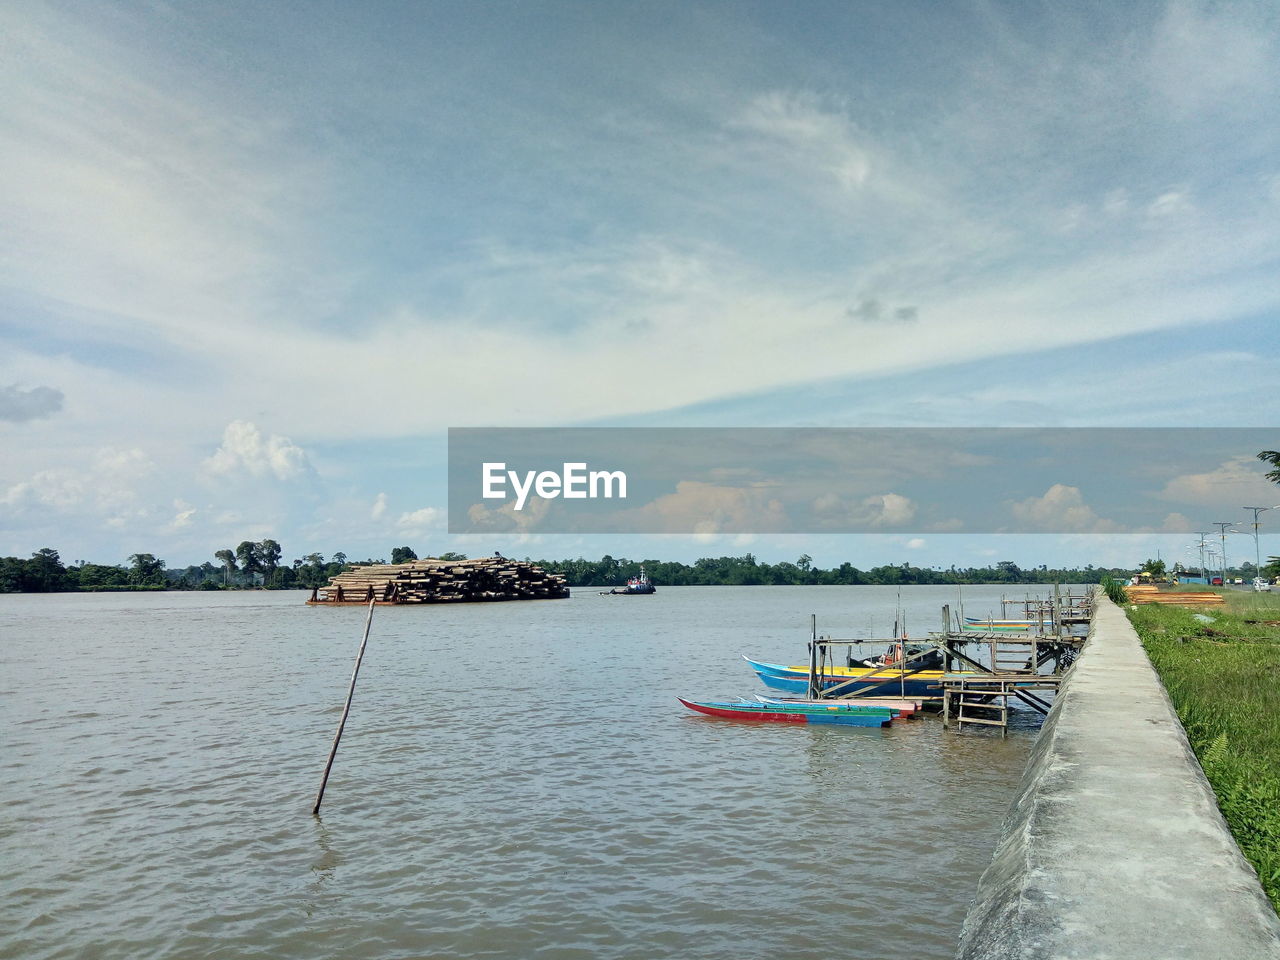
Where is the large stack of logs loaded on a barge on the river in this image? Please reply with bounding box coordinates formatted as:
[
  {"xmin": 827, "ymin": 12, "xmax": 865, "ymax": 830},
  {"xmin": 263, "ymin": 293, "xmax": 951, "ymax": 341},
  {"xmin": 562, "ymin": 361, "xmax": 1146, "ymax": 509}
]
[{"xmin": 308, "ymin": 557, "xmax": 568, "ymax": 604}]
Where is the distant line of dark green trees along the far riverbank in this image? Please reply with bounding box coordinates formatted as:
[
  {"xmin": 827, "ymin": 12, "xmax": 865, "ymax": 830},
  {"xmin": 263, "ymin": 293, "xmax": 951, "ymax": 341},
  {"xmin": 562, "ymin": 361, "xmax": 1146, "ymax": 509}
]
[{"xmin": 0, "ymin": 540, "xmax": 1152, "ymax": 593}]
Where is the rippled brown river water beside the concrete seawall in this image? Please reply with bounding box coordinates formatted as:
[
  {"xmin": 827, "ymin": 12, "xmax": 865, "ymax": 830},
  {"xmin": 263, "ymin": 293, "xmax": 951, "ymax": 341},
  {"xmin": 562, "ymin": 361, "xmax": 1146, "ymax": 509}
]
[{"xmin": 0, "ymin": 588, "xmax": 1036, "ymax": 960}]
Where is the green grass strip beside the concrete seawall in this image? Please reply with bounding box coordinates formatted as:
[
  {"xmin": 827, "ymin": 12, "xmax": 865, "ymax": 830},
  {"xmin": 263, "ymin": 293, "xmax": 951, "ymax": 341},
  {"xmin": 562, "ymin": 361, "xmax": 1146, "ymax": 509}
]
[{"xmin": 1129, "ymin": 590, "xmax": 1280, "ymax": 911}]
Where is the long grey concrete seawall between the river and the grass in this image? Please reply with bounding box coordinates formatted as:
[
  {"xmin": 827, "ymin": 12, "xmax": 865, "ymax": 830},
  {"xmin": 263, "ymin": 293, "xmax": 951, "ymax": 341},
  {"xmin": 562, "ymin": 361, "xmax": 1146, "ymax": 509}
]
[{"xmin": 956, "ymin": 596, "xmax": 1280, "ymax": 960}]
